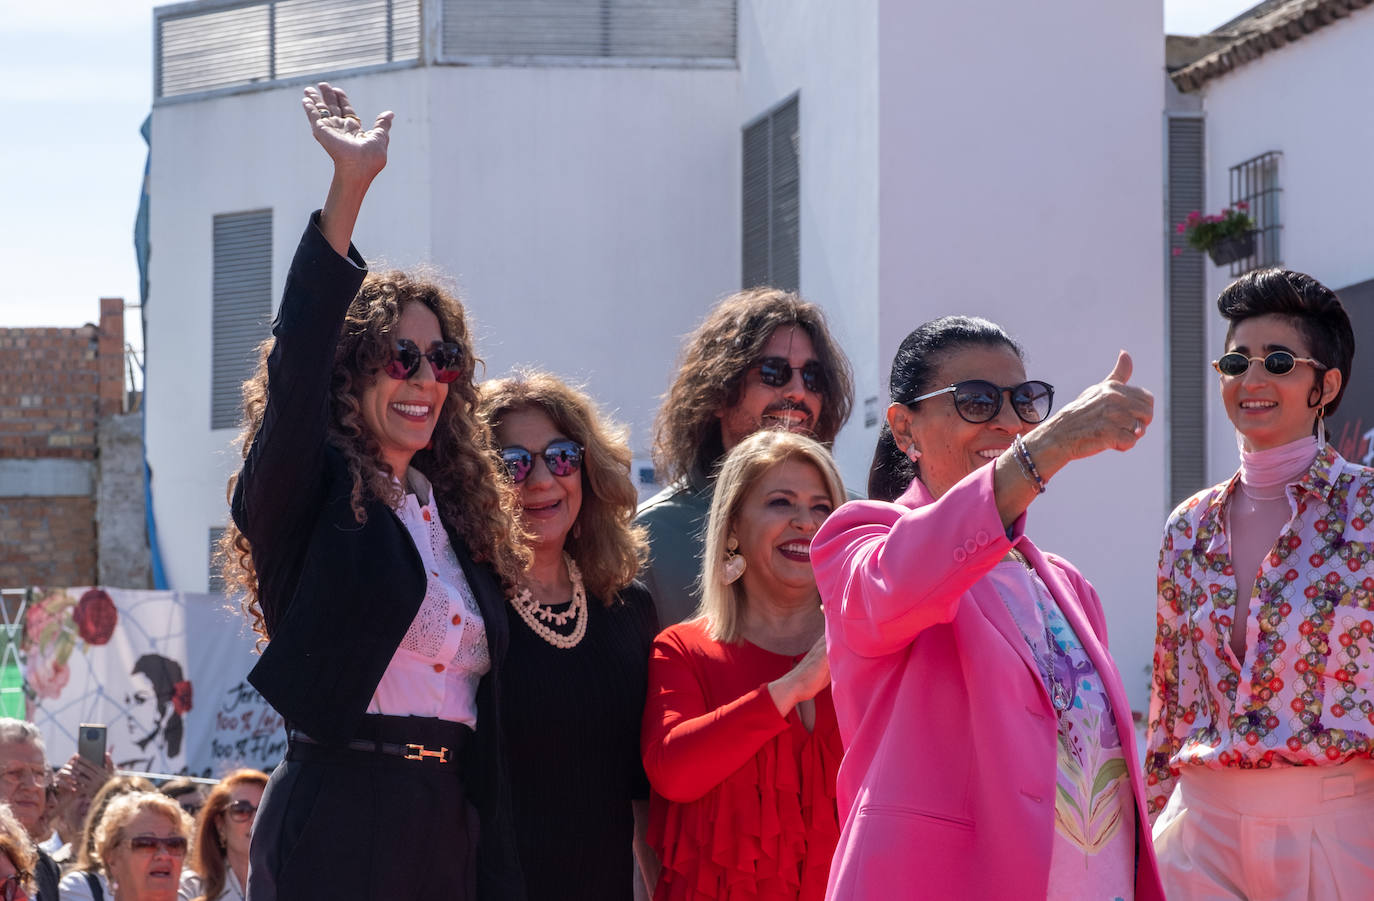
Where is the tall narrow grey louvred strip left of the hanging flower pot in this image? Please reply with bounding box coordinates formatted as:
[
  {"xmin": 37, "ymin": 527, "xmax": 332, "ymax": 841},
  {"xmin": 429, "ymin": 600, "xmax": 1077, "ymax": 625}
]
[{"xmin": 1168, "ymin": 117, "xmax": 1212, "ymax": 504}]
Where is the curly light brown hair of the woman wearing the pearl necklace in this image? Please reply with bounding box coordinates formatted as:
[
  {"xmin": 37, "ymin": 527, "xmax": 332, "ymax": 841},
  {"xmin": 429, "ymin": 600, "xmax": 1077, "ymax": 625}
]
[{"xmin": 478, "ymin": 371, "xmax": 649, "ymax": 606}]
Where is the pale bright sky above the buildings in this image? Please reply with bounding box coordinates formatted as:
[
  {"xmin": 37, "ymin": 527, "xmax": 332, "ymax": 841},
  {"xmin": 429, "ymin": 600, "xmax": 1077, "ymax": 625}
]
[{"xmin": 0, "ymin": 0, "xmax": 1257, "ymax": 370}]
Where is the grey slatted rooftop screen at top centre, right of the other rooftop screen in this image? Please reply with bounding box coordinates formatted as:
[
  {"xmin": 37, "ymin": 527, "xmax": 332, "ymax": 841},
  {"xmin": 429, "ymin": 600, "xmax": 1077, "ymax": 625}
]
[{"xmin": 442, "ymin": 0, "xmax": 736, "ymax": 63}]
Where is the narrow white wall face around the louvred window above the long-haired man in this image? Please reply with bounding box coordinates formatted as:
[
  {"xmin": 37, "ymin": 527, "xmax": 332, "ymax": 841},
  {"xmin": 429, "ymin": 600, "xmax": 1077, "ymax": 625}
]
[{"xmin": 732, "ymin": 0, "xmax": 892, "ymax": 492}]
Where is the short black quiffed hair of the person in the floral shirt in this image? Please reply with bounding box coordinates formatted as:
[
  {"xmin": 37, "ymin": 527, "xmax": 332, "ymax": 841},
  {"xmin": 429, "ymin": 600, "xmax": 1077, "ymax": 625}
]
[{"xmin": 1216, "ymin": 269, "xmax": 1355, "ymax": 416}]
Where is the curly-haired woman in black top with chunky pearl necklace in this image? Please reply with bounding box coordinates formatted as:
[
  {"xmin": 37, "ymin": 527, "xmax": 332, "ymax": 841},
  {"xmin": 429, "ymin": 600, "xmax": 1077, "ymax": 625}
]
[{"xmin": 480, "ymin": 372, "xmax": 658, "ymax": 901}]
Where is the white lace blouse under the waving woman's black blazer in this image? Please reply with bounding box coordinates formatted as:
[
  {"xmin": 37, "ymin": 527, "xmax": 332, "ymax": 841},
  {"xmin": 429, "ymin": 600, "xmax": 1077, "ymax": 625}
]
[{"xmin": 367, "ymin": 468, "xmax": 492, "ymax": 729}]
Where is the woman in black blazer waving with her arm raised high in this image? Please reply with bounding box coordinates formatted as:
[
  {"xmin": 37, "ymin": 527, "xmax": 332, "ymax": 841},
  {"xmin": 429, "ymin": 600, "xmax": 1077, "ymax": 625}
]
[{"xmin": 225, "ymin": 82, "xmax": 528, "ymax": 901}]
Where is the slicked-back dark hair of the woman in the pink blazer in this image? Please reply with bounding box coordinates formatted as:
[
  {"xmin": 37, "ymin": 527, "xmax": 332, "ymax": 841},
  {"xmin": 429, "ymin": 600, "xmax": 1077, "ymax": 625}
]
[{"xmin": 868, "ymin": 316, "xmax": 1024, "ymax": 501}]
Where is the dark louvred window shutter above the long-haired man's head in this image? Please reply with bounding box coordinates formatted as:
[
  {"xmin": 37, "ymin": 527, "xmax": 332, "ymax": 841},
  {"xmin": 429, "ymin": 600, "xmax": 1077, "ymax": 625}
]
[{"xmin": 741, "ymin": 95, "xmax": 801, "ymax": 291}]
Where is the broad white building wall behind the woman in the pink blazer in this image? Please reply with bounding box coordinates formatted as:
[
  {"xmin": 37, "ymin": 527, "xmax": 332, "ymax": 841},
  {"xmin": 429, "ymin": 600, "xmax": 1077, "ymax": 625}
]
[{"xmin": 878, "ymin": 0, "xmax": 1168, "ymax": 710}]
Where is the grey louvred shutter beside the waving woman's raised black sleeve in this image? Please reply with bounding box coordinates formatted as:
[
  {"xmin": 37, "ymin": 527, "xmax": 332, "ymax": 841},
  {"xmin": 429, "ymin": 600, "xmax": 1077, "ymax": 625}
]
[{"xmin": 210, "ymin": 210, "xmax": 272, "ymax": 429}]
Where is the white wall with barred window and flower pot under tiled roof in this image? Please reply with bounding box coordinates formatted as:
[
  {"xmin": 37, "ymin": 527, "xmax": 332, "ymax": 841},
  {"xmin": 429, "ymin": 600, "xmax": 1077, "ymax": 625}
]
[{"xmin": 1202, "ymin": 10, "xmax": 1374, "ymax": 482}]
